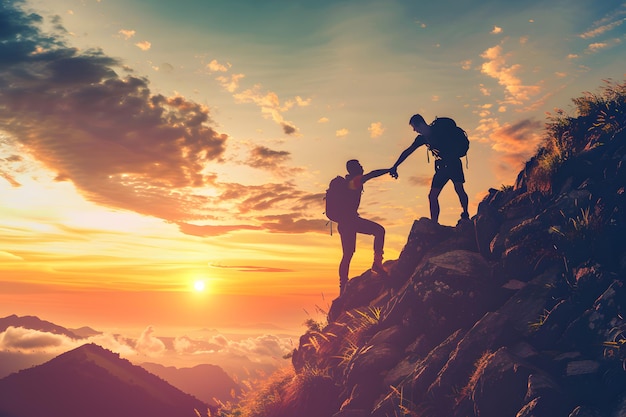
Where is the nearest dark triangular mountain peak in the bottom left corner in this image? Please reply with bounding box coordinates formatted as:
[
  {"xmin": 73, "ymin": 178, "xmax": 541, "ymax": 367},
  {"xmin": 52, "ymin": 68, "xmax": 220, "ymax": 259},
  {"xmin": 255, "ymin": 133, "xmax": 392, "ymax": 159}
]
[{"xmin": 0, "ymin": 343, "xmax": 208, "ymax": 417}]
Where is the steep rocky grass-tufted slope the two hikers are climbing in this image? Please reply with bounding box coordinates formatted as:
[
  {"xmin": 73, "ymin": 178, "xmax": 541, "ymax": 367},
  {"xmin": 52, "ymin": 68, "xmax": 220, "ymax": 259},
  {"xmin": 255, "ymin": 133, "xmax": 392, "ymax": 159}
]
[{"xmin": 286, "ymin": 91, "xmax": 626, "ymax": 417}]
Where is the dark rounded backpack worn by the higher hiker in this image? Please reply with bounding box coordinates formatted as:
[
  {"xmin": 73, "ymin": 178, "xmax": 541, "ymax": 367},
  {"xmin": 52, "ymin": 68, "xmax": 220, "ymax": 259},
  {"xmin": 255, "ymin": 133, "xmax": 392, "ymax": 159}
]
[{"xmin": 428, "ymin": 117, "xmax": 469, "ymax": 159}]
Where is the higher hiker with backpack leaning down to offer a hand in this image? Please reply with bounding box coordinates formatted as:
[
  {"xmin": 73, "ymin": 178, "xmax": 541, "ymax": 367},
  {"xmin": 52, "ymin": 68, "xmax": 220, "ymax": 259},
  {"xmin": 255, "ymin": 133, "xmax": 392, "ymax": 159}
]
[{"xmin": 389, "ymin": 114, "xmax": 469, "ymax": 223}]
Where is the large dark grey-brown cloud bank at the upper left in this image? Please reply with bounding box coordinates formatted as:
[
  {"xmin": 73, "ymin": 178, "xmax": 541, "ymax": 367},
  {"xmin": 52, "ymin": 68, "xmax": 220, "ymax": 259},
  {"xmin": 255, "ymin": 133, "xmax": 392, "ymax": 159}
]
[{"xmin": 0, "ymin": 2, "xmax": 227, "ymax": 221}]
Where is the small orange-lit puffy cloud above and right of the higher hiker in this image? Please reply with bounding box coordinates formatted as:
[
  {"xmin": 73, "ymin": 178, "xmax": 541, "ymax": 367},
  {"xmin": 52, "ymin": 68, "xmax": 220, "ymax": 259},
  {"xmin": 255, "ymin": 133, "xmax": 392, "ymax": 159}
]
[{"xmin": 481, "ymin": 45, "xmax": 540, "ymax": 104}]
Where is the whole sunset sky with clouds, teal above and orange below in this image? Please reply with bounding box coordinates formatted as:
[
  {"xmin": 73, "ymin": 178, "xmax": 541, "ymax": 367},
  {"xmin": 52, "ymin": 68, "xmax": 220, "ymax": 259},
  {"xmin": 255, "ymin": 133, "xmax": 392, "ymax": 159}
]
[{"xmin": 0, "ymin": 0, "xmax": 626, "ymax": 338}]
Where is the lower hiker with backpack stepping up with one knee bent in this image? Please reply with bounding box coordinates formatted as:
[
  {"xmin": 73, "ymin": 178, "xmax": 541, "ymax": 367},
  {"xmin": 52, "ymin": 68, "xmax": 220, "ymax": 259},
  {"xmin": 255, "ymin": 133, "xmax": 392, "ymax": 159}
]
[{"xmin": 326, "ymin": 159, "xmax": 389, "ymax": 295}]
